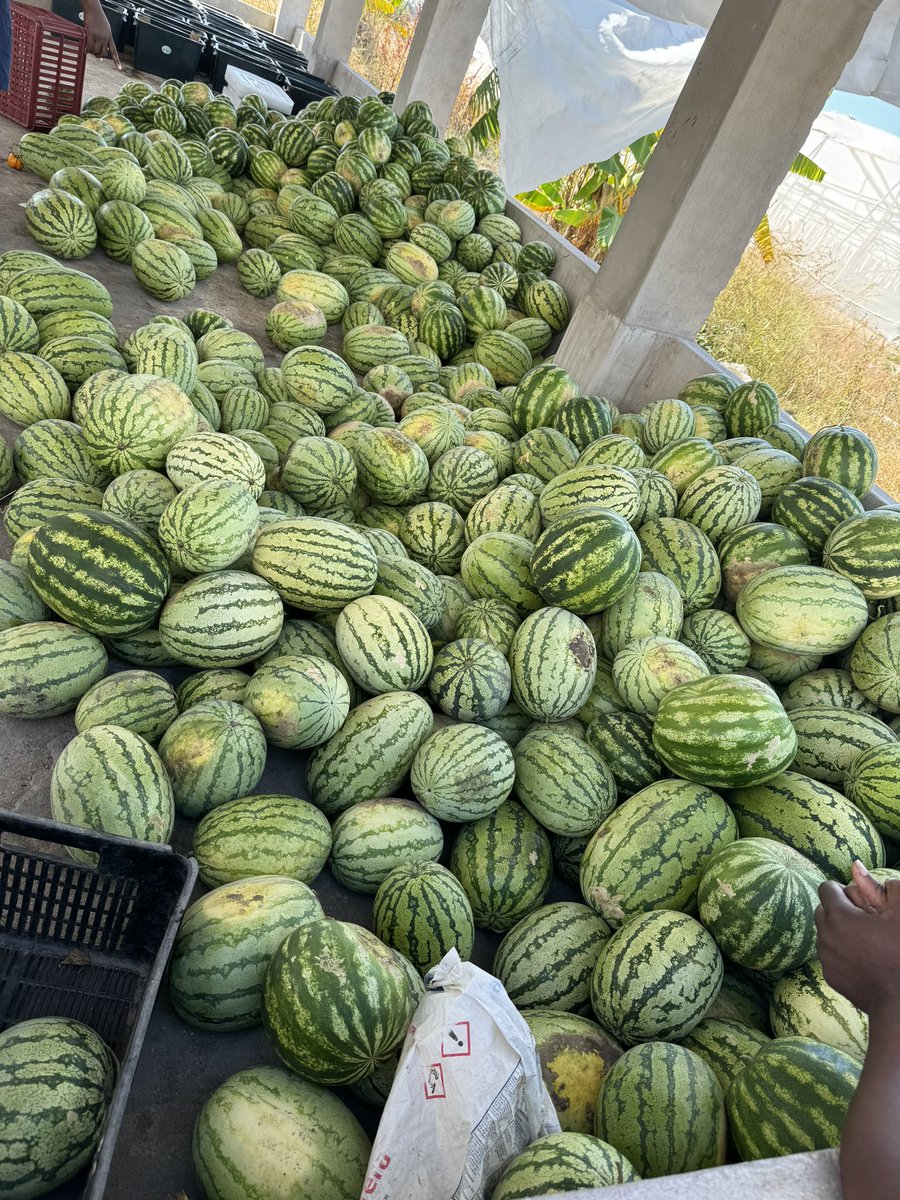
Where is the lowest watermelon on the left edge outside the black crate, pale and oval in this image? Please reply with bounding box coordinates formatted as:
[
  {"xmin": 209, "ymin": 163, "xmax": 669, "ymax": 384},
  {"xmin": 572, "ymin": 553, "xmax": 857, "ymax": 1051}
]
[{"xmin": 0, "ymin": 620, "xmax": 107, "ymax": 719}]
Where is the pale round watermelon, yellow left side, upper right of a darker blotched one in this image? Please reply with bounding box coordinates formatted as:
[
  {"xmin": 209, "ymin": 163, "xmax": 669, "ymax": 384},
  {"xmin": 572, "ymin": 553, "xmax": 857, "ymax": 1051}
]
[{"xmin": 241, "ymin": 654, "xmax": 350, "ymax": 749}]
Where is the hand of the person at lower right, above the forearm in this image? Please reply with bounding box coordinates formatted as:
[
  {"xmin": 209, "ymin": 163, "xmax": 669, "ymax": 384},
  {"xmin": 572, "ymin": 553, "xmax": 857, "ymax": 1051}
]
[{"xmin": 816, "ymin": 869, "xmax": 900, "ymax": 1016}]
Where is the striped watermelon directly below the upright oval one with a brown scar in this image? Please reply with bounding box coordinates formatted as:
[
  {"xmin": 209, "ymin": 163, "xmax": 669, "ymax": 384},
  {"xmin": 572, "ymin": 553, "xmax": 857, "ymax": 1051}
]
[{"xmin": 515, "ymin": 727, "xmax": 617, "ymax": 838}]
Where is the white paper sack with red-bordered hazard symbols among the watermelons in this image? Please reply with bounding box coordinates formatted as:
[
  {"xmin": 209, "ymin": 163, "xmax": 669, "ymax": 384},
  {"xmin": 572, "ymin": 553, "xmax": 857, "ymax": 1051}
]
[{"xmin": 361, "ymin": 950, "xmax": 559, "ymax": 1200}]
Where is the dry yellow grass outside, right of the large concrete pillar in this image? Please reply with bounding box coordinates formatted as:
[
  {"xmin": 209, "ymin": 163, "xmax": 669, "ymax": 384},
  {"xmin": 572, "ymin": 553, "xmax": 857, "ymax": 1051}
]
[{"xmin": 700, "ymin": 246, "xmax": 900, "ymax": 496}]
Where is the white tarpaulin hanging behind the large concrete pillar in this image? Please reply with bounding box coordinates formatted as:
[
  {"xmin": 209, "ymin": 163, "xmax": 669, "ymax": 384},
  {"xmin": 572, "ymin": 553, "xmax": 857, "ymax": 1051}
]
[{"xmin": 486, "ymin": 0, "xmax": 900, "ymax": 192}]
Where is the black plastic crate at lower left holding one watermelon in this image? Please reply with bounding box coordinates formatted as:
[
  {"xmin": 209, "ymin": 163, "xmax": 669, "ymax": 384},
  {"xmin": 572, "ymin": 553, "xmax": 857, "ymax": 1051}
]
[{"xmin": 0, "ymin": 810, "xmax": 197, "ymax": 1200}]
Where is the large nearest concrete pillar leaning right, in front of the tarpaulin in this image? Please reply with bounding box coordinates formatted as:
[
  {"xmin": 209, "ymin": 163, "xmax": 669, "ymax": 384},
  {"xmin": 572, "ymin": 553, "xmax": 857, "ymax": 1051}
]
[{"xmin": 557, "ymin": 0, "xmax": 878, "ymax": 408}]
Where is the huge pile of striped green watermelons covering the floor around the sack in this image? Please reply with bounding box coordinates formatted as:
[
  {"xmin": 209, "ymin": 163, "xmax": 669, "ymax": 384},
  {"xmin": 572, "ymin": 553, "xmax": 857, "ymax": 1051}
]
[{"xmin": 0, "ymin": 85, "xmax": 900, "ymax": 1200}]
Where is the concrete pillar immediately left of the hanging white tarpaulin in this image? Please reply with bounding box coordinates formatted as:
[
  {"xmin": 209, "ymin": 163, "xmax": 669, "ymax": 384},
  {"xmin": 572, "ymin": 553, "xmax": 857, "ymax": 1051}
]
[{"xmin": 394, "ymin": 0, "xmax": 491, "ymax": 132}]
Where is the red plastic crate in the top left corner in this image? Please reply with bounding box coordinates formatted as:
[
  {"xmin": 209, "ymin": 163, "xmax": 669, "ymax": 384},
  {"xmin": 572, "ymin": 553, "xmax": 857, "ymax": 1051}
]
[{"xmin": 0, "ymin": 0, "xmax": 86, "ymax": 130}]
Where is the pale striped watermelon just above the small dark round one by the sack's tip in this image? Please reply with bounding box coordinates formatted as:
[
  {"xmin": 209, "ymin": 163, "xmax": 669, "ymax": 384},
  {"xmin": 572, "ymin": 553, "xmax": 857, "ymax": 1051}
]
[{"xmin": 330, "ymin": 797, "xmax": 444, "ymax": 894}]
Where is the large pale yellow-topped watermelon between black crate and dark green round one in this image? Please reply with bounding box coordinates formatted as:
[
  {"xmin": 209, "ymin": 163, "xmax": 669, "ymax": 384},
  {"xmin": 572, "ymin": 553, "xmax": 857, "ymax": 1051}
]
[{"xmin": 169, "ymin": 875, "xmax": 323, "ymax": 1031}]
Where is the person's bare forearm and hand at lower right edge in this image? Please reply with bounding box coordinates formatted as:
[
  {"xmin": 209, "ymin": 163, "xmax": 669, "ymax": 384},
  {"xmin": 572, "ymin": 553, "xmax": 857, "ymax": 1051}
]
[{"xmin": 816, "ymin": 864, "xmax": 900, "ymax": 1200}]
